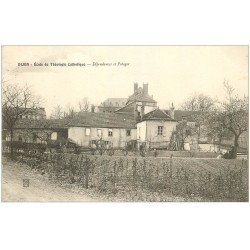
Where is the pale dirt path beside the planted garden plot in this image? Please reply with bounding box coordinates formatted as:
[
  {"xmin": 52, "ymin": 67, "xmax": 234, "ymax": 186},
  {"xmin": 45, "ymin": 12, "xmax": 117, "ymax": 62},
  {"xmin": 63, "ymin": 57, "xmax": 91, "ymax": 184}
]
[{"xmin": 2, "ymin": 159, "xmax": 95, "ymax": 202}]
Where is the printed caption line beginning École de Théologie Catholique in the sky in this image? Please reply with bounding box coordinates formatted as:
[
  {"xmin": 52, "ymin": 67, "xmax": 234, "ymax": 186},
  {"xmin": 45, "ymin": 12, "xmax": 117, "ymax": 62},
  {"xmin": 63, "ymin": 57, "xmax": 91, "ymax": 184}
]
[{"xmin": 18, "ymin": 62, "xmax": 130, "ymax": 67}]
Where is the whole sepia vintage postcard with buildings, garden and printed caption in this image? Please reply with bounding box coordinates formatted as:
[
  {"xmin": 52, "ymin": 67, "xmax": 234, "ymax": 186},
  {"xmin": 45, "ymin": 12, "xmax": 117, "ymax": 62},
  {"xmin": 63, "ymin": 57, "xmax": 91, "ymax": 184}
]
[{"xmin": 1, "ymin": 46, "xmax": 249, "ymax": 202}]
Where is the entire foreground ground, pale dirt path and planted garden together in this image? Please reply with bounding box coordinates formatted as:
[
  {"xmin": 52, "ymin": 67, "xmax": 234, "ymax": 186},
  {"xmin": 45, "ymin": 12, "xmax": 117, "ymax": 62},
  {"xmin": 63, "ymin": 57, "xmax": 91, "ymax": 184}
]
[{"xmin": 2, "ymin": 154, "xmax": 248, "ymax": 202}]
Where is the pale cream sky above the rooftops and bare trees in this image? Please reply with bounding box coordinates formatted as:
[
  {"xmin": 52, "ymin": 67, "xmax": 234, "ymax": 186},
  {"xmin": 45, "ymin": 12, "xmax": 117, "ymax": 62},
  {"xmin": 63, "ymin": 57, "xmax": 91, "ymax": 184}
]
[{"xmin": 2, "ymin": 46, "xmax": 248, "ymax": 115}]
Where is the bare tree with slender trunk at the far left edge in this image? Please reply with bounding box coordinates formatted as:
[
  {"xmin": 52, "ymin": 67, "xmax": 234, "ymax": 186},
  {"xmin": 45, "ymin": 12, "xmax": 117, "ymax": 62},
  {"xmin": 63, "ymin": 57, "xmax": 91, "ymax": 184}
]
[{"xmin": 2, "ymin": 84, "xmax": 40, "ymax": 160}]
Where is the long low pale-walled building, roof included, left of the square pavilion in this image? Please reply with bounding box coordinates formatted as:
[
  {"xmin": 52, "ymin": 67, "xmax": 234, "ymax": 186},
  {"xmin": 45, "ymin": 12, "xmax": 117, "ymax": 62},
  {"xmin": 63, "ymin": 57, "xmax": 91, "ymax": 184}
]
[{"xmin": 68, "ymin": 112, "xmax": 136, "ymax": 147}]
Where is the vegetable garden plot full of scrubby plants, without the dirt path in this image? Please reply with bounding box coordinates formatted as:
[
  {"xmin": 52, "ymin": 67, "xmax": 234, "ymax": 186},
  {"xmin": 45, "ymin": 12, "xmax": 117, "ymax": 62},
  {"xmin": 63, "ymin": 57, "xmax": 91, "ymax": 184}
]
[{"xmin": 15, "ymin": 153, "xmax": 248, "ymax": 201}]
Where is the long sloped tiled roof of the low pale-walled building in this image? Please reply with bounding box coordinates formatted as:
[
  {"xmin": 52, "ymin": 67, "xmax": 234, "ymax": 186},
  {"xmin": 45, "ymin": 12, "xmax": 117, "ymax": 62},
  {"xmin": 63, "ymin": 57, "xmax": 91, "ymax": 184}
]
[{"xmin": 68, "ymin": 112, "xmax": 136, "ymax": 129}]
